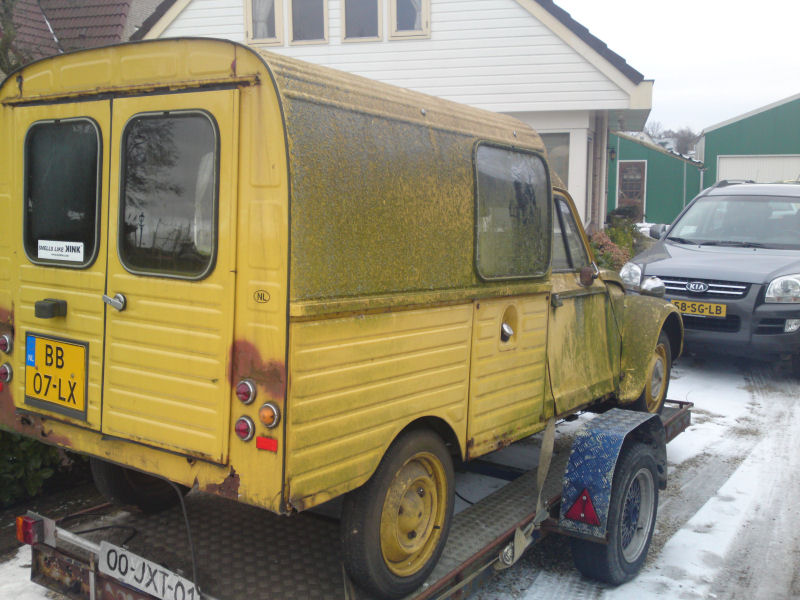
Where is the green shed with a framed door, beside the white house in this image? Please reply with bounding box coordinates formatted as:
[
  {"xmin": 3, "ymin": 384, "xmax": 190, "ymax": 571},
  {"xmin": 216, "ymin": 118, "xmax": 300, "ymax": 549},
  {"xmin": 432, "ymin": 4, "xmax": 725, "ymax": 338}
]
[{"xmin": 607, "ymin": 132, "xmax": 703, "ymax": 223}]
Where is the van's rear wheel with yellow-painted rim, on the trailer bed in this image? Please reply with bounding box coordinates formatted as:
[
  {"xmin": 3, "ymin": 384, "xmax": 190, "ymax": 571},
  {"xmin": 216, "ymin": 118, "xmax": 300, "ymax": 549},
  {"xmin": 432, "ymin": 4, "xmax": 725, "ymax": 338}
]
[{"xmin": 341, "ymin": 429, "xmax": 454, "ymax": 598}]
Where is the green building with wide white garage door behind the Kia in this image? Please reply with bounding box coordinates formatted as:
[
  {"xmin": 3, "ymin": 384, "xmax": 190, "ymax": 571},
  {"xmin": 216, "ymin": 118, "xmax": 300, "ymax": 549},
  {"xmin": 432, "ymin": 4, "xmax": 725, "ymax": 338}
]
[{"xmin": 697, "ymin": 94, "xmax": 800, "ymax": 186}]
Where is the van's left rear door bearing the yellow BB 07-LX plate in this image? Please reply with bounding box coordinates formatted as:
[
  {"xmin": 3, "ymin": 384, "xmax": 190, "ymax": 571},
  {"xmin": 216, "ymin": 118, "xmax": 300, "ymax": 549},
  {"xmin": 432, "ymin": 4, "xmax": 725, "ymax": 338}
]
[{"xmin": 12, "ymin": 101, "xmax": 111, "ymax": 429}]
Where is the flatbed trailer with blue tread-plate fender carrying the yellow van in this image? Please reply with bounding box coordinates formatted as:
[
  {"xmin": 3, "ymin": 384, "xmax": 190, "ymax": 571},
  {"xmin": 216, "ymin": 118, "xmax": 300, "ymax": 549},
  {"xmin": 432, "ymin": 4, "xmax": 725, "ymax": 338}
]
[{"xmin": 17, "ymin": 400, "xmax": 692, "ymax": 600}]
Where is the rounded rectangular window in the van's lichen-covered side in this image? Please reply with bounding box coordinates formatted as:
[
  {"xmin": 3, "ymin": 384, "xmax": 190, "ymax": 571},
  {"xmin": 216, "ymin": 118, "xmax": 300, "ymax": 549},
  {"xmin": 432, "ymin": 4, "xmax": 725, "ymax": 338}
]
[{"xmin": 475, "ymin": 144, "xmax": 552, "ymax": 279}]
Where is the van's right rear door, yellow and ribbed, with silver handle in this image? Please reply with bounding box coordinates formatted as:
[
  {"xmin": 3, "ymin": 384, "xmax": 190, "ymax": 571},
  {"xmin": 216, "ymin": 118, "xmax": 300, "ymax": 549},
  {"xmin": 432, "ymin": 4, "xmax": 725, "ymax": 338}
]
[{"xmin": 102, "ymin": 90, "xmax": 238, "ymax": 462}]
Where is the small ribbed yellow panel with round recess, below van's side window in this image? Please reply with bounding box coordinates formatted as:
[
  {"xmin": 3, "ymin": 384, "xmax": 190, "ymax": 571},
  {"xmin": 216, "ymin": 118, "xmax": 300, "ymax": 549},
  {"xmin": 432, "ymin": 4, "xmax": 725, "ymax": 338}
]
[{"xmin": 467, "ymin": 294, "xmax": 548, "ymax": 458}]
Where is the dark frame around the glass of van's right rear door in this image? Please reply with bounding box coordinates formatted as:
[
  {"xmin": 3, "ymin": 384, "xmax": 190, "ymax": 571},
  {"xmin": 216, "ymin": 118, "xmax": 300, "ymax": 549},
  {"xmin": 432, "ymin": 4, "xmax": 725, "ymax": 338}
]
[{"xmin": 116, "ymin": 108, "xmax": 221, "ymax": 281}]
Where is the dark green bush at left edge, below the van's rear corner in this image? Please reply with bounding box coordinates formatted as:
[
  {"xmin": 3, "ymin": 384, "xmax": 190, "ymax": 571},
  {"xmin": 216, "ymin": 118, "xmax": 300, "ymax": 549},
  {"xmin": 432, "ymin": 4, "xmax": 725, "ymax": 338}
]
[{"xmin": 0, "ymin": 431, "xmax": 64, "ymax": 507}]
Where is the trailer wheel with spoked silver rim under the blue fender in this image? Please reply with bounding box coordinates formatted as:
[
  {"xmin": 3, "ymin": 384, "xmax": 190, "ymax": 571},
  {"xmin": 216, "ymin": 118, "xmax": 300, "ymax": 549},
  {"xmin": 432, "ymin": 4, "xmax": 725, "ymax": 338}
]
[{"xmin": 570, "ymin": 444, "xmax": 658, "ymax": 585}]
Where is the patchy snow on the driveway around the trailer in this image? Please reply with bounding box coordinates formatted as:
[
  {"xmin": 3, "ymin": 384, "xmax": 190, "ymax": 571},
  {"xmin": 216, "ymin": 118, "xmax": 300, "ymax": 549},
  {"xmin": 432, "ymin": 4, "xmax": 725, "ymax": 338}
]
[{"xmin": 0, "ymin": 357, "xmax": 800, "ymax": 600}]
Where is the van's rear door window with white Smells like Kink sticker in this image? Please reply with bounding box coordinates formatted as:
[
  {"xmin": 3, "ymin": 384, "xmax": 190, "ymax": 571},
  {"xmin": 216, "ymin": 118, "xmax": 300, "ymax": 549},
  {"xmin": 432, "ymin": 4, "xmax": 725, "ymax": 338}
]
[{"xmin": 23, "ymin": 119, "xmax": 100, "ymax": 267}]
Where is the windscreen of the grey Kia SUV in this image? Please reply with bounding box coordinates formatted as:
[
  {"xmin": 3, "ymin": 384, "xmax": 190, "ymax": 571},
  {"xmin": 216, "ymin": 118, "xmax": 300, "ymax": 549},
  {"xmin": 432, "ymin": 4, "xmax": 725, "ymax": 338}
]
[{"xmin": 668, "ymin": 196, "xmax": 800, "ymax": 250}]
